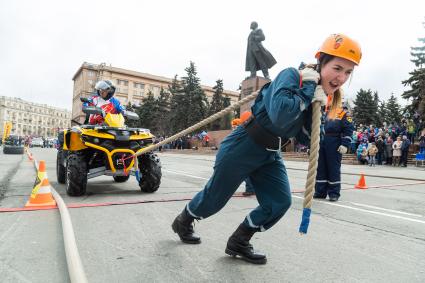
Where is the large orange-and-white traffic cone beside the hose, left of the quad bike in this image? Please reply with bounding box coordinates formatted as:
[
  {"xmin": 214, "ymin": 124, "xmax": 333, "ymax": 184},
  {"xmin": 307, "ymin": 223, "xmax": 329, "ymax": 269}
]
[{"xmin": 25, "ymin": 160, "xmax": 56, "ymax": 207}]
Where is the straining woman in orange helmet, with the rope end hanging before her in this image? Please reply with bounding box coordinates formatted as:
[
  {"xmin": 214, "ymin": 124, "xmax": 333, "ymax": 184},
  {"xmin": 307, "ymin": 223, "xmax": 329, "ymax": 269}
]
[{"xmin": 172, "ymin": 34, "xmax": 361, "ymax": 264}]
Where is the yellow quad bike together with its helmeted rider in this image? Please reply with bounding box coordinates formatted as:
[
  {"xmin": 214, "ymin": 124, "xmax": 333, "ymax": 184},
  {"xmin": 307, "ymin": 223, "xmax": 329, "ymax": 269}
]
[{"xmin": 56, "ymin": 80, "xmax": 162, "ymax": 196}]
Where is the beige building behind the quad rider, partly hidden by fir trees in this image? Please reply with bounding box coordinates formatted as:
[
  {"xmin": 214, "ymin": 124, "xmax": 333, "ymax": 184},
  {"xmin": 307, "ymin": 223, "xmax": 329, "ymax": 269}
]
[{"xmin": 72, "ymin": 62, "xmax": 239, "ymax": 123}]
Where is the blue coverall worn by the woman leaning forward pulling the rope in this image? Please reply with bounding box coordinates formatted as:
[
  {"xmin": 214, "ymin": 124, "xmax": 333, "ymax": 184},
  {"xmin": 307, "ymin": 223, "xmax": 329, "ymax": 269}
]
[{"xmin": 186, "ymin": 68, "xmax": 316, "ymax": 231}]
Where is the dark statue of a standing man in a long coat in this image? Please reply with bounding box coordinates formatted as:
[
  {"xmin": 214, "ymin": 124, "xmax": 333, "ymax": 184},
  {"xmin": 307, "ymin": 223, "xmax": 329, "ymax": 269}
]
[{"xmin": 245, "ymin": 22, "xmax": 276, "ymax": 79}]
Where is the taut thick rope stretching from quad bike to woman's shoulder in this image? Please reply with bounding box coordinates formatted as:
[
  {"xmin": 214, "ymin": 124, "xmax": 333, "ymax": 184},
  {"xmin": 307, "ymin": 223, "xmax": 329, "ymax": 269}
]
[{"xmin": 133, "ymin": 91, "xmax": 259, "ymax": 157}]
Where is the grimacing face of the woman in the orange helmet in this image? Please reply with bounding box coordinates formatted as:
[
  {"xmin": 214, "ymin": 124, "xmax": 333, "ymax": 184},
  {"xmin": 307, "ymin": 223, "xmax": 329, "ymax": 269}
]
[{"xmin": 320, "ymin": 57, "xmax": 355, "ymax": 95}]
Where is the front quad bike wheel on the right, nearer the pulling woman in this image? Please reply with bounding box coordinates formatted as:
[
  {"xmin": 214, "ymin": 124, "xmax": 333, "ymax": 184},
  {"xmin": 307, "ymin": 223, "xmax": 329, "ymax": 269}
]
[{"xmin": 138, "ymin": 152, "xmax": 162, "ymax": 193}]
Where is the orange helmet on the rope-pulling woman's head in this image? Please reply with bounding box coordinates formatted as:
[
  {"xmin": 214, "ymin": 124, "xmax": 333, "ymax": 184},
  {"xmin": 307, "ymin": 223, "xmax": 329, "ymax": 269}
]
[{"xmin": 315, "ymin": 33, "xmax": 362, "ymax": 65}]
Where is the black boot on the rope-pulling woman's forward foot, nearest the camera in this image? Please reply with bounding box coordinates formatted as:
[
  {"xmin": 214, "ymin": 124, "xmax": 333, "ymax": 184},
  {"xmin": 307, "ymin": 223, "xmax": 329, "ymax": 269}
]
[{"xmin": 225, "ymin": 223, "xmax": 267, "ymax": 264}]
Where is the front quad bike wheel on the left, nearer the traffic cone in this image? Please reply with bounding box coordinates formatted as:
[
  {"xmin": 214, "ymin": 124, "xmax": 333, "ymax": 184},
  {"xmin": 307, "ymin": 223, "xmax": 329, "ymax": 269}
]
[{"xmin": 66, "ymin": 153, "xmax": 88, "ymax": 196}]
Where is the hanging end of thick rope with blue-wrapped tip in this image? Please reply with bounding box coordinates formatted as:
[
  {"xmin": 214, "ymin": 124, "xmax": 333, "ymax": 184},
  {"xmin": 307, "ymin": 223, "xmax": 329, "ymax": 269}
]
[{"xmin": 299, "ymin": 102, "xmax": 321, "ymax": 234}]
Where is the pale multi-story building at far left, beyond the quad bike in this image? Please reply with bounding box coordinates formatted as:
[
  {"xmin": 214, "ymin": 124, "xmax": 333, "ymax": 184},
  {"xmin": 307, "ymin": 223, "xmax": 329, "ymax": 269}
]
[{"xmin": 0, "ymin": 96, "xmax": 71, "ymax": 137}]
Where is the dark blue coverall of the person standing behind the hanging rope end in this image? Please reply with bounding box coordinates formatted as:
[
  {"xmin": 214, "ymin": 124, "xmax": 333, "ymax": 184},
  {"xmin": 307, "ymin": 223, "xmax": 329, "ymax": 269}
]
[{"xmin": 314, "ymin": 110, "xmax": 354, "ymax": 198}]
